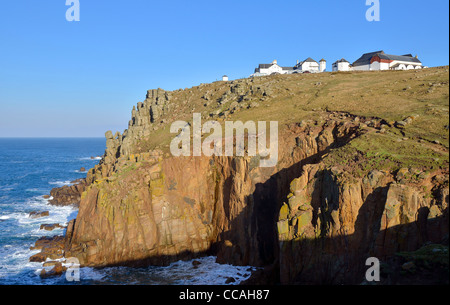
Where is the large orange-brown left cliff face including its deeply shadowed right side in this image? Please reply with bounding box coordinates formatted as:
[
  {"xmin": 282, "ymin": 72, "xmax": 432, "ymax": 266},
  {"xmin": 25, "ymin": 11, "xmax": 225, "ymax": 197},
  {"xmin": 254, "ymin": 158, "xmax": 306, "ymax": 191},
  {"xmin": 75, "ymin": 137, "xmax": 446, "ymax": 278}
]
[{"xmin": 65, "ymin": 117, "xmax": 362, "ymax": 266}]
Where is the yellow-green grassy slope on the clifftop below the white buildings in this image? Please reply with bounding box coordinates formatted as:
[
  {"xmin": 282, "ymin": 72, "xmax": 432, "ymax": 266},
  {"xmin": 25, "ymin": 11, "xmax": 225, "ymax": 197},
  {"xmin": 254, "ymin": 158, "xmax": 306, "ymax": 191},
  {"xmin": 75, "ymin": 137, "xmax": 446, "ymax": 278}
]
[{"xmin": 132, "ymin": 66, "xmax": 449, "ymax": 176}]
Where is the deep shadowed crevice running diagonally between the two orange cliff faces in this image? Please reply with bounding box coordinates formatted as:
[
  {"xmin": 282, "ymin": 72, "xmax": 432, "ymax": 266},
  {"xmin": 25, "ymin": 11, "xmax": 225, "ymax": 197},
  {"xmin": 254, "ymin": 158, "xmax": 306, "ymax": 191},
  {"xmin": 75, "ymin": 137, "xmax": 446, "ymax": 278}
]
[{"xmin": 213, "ymin": 120, "xmax": 361, "ymax": 270}]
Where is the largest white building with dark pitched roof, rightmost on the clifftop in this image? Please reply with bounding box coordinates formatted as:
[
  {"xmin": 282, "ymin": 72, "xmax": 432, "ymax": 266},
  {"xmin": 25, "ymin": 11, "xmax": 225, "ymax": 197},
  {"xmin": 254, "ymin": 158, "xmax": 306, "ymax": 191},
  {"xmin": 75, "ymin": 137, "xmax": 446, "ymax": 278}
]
[{"xmin": 351, "ymin": 51, "xmax": 423, "ymax": 71}]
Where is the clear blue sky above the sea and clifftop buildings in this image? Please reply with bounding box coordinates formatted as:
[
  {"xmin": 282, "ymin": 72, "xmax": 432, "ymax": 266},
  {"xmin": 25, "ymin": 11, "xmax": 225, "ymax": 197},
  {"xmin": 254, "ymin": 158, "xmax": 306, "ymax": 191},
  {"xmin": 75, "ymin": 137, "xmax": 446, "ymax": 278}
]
[{"xmin": 0, "ymin": 0, "xmax": 449, "ymax": 137}]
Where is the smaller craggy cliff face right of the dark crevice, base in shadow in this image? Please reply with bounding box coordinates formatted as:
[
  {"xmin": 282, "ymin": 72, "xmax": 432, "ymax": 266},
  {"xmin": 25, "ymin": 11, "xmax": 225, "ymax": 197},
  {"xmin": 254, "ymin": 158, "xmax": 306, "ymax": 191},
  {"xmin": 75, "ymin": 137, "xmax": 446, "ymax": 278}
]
[{"xmin": 277, "ymin": 164, "xmax": 449, "ymax": 284}]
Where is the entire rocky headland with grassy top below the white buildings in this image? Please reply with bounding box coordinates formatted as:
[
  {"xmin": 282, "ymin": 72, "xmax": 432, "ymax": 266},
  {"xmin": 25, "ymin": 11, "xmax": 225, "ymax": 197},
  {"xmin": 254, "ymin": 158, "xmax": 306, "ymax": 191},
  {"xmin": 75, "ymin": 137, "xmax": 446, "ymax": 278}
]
[{"xmin": 43, "ymin": 70, "xmax": 449, "ymax": 283}]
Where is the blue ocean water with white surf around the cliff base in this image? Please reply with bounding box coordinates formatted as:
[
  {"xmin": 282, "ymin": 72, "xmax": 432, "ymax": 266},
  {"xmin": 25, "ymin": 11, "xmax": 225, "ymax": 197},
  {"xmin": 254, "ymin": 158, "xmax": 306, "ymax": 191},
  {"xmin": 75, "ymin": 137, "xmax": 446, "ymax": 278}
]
[{"xmin": 0, "ymin": 138, "xmax": 254, "ymax": 285}]
